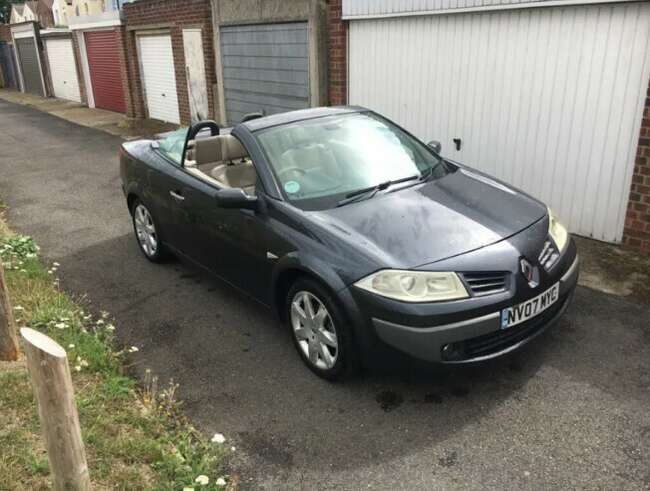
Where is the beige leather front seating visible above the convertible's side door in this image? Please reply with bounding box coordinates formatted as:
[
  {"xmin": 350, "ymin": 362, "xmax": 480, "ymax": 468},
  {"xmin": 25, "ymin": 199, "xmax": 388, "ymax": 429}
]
[{"xmin": 187, "ymin": 135, "xmax": 257, "ymax": 194}]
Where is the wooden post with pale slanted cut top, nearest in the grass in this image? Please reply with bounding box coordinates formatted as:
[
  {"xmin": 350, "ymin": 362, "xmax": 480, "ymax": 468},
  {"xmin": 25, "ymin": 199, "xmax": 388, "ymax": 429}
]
[{"xmin": 20, "ymin": 327, "xmax": 90, "ymax": 491}]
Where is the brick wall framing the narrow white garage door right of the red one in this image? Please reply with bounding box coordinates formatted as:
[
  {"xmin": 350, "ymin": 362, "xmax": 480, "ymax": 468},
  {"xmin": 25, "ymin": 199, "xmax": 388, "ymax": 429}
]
[{"xmin": 124, "ymin": 0, "xmax": 217, "ymax": 124}]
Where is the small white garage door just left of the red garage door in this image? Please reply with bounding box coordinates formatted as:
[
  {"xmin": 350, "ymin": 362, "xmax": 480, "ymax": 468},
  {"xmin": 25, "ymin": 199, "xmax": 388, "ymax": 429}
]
[{"xmin": 45, "ymin": 39, "xmax": 81, "ymax": 102}]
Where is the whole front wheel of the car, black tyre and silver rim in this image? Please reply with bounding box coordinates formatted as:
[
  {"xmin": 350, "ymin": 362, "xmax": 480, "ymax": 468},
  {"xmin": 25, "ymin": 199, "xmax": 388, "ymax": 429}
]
[{"xmin": 286, "ymin": 278, "xmax": 355, "ymax": 380}]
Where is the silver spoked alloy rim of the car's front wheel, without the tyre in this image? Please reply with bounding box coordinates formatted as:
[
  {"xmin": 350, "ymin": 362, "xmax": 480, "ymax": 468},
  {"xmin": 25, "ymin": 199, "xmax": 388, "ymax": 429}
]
[{"xmin": 291, "ymin": 291, "xmax": 339, "ymax": 370}]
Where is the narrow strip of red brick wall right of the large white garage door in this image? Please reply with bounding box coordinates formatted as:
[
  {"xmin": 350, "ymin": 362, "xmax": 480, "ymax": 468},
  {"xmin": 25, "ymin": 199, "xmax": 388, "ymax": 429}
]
[{"xmin": 623, "ymin": 79, "xmax": 650, "ymax": 252}]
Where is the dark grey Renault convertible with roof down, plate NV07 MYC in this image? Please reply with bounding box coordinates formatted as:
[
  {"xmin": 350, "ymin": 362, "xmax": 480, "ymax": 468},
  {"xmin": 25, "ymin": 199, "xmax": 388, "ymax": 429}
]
[{"xmin": 121, "ymin": 107, "xmax": 578, "ymax": 379}]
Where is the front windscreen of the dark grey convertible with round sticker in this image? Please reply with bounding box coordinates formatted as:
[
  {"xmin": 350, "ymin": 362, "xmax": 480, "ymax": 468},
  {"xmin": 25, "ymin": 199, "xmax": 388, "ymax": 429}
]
[{"xmin": 256, "ymin": 113, "xmax": 447, "ymax": 210}]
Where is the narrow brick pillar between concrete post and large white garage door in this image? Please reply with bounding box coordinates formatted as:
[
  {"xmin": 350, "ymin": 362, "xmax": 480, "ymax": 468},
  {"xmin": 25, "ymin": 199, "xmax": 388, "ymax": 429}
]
[{"xmin": 327, "ymin": 0, "xmax": 348, "ymax": 106}]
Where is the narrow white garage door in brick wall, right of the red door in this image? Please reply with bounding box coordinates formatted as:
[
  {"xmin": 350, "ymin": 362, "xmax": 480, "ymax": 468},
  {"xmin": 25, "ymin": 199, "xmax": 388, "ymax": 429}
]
[{"xmin": 138, "ymin": 35, "xmax": 181, "ymax": 123}]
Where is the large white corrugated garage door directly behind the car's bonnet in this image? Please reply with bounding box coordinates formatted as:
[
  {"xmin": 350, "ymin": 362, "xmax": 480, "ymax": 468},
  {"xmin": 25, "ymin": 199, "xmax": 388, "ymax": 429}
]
[{"xmin": 349, "ymin": 2, "xmax": 650, "ymax": 242}]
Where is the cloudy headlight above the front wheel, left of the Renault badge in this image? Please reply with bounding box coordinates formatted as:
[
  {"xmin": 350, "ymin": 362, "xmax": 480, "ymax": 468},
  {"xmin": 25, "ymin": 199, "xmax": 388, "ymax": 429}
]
[{"xmin": 355, "ymin": 269, "xmax": 469, "ymax": 302}]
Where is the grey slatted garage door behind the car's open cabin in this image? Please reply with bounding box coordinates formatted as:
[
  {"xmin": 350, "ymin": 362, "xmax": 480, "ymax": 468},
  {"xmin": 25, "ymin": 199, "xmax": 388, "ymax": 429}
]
[{"xmin": 220, "ymin": 22, "xmax": 309, "ymax": 123}]
